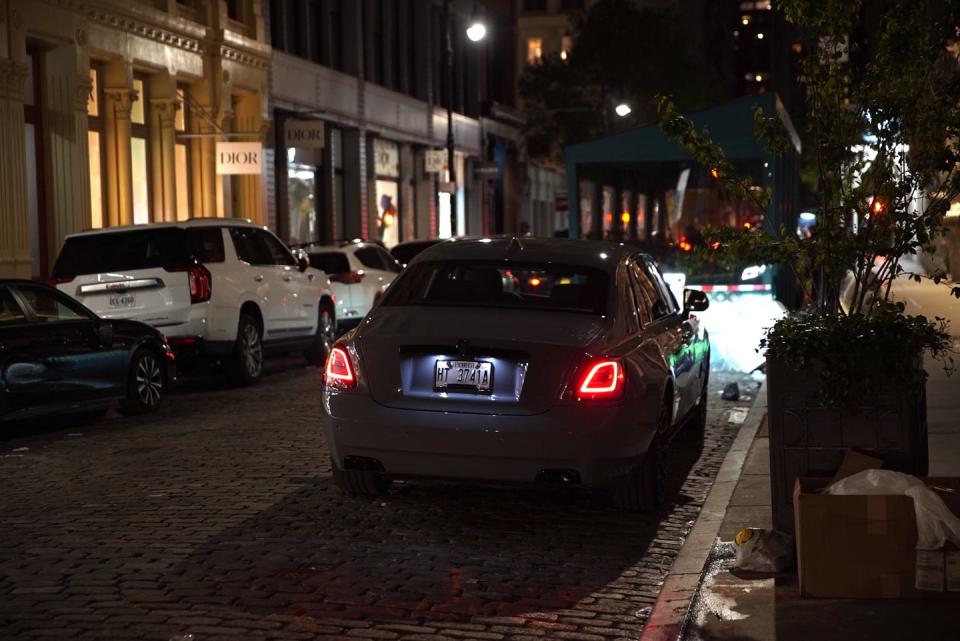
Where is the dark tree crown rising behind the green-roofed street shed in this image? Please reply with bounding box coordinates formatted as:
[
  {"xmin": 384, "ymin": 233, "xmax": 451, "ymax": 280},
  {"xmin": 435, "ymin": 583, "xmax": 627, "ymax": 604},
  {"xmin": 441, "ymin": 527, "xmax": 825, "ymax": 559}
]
[{"xmin": 519, "ymin": 0, "xmax": 719, "ymax": 163}]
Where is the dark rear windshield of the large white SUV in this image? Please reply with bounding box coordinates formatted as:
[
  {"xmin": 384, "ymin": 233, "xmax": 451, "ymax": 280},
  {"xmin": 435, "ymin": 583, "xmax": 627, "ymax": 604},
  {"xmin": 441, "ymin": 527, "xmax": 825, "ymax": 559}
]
[{"xmin": 53, "ymin": 227, "xmax": 223, "ymax": 278}]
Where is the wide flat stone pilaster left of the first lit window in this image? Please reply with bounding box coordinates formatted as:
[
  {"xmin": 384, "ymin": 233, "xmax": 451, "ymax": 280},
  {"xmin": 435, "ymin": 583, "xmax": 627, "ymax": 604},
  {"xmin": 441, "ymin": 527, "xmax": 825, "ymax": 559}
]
[{"xmin": 42, "ymin": 45, "xmax": 92, "ymax": 262}]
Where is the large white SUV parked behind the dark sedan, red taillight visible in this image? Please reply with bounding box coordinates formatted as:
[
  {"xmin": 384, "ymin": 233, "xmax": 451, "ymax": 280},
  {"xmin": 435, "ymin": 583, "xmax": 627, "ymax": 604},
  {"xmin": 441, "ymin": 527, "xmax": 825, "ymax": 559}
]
[{"xmin": 52, "ymin": 218, "xmax": 336, "ymax": 385}]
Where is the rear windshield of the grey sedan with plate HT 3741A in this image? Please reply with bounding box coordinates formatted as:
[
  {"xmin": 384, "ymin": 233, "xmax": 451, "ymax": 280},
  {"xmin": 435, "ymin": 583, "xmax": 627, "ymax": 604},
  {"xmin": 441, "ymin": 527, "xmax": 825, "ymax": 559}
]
[{"xmin": 381, "ymin": 261, "xmax": 609, "ymax": 314}]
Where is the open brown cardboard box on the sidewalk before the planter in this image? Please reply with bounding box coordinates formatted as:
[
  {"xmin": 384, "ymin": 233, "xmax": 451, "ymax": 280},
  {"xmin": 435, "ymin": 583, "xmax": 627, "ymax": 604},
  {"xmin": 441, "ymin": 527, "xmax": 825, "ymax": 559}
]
[{"xmin": 793, "ymin": 478, "xmax": 960, "ymax": 599}]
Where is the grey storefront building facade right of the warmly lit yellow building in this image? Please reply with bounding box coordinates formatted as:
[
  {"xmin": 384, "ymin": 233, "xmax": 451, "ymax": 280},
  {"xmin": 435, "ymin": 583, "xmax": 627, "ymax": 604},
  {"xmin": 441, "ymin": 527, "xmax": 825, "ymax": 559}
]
[{"xmin": 265, "ymin": 0, "xmax": 522, "ymax": 247}]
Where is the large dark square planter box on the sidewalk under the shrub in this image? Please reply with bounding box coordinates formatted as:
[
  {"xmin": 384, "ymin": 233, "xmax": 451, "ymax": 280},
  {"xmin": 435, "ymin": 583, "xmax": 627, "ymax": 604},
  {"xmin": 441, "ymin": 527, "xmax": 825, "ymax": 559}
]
[{"xmin": 767, "ymin": 357, "xmax": 929, "ymax": 533}]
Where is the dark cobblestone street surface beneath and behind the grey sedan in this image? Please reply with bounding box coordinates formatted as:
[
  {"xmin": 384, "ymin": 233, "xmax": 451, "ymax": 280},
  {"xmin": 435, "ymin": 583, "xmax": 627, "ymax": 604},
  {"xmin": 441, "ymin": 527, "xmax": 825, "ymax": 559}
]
[{"xmin": 0, "ymin": 361, "xmax": 749, "ymax": 641}]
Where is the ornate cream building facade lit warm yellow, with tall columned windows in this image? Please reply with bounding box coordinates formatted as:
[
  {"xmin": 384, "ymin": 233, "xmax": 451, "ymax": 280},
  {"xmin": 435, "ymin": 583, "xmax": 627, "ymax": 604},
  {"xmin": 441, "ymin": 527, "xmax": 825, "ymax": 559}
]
[{"xmin": 0, "ymin": 0, "xmax": 270, "ymax": 278}]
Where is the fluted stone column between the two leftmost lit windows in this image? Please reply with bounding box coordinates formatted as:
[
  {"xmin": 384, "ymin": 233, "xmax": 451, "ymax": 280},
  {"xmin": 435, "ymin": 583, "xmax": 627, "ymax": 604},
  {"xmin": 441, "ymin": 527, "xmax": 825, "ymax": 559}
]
[{"xmin": 103, "ymin": 87, "xmax": 137, "ymax": 227}]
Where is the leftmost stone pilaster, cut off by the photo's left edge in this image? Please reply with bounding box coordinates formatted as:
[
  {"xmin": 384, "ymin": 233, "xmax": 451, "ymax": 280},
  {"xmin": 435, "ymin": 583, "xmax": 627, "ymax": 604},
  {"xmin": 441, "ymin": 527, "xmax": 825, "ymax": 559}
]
[{"xmin": 0, "ymin": 59, "xmax": 33, "ymax": 278}]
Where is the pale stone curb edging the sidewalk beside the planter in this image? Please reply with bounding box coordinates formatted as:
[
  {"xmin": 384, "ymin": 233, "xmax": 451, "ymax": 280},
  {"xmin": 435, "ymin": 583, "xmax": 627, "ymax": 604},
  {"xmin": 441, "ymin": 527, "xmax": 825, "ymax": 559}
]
[{"xmin": 640, "ymin": 381, "xmax": 767, "ymax": 641}]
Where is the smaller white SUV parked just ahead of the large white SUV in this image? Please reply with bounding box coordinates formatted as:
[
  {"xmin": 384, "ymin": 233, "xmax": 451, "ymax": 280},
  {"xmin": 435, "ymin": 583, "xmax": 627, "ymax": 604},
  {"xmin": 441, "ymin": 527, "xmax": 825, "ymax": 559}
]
[{"xmin": 305, "ymin": 240, "xmax": 400, "ymax": 332}]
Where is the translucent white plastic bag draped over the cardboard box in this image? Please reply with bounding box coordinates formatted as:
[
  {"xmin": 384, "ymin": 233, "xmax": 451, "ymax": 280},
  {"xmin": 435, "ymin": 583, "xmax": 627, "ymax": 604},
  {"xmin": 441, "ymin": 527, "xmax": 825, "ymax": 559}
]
[{"xmin": 826, "ymin": 470, "xmax": 960, "ymax": 550}]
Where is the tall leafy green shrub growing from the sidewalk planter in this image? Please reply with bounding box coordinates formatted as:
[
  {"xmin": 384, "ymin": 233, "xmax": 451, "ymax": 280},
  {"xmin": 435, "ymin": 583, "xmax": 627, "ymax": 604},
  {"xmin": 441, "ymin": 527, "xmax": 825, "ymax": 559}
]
[{"xmin": 659, "ymin": 0, "xmax": 960, "ymax": 406}]
